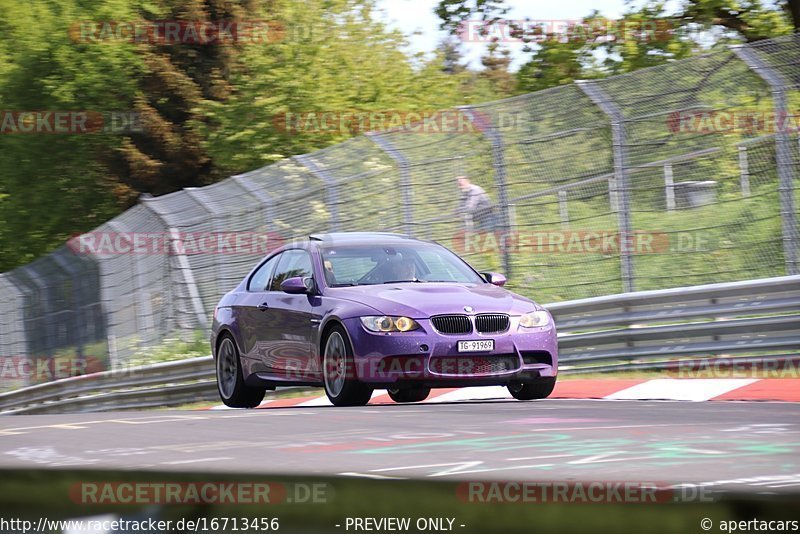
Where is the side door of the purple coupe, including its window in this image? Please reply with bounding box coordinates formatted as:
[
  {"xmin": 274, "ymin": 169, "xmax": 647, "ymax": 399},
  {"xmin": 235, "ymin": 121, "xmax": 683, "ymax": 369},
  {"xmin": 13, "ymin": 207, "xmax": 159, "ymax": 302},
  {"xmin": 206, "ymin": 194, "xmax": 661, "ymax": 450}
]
[{"xmin": 263, "ymin": 249, "xmax": 319, "ymax": 382}]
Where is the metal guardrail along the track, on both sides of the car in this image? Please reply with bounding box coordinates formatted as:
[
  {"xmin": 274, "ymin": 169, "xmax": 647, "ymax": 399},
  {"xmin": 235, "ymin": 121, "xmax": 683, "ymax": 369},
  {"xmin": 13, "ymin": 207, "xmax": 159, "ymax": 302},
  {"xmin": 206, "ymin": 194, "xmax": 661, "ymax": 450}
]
[{"xmin": 0, "ymin": 276, "xmax": 800, "ymax": 414}]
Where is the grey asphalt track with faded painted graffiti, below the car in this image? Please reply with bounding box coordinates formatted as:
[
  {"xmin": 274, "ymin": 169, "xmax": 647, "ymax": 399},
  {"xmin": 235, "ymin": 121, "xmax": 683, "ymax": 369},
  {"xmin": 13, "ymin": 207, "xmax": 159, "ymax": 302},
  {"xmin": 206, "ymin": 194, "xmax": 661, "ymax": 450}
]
[{"xmin": 0, "ymin": 400, "xmax": 800, "ymax": 493}]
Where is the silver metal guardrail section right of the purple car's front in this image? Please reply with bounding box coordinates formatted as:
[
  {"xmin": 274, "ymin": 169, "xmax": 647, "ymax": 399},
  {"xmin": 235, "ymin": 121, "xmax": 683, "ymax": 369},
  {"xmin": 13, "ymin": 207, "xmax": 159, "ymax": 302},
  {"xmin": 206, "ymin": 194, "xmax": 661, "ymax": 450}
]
[{"xmin": 546, "ymin": 276, "xmax": 800, "ymax": 367}]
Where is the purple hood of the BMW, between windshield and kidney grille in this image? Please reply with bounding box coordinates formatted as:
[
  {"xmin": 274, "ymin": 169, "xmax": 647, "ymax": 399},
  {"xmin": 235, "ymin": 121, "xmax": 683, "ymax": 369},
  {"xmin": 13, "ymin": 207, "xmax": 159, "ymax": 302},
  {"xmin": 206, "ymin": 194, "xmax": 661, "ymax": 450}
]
[{"xmin": 331, "ymin": 282, "xmax": 541, "ymax": 319}]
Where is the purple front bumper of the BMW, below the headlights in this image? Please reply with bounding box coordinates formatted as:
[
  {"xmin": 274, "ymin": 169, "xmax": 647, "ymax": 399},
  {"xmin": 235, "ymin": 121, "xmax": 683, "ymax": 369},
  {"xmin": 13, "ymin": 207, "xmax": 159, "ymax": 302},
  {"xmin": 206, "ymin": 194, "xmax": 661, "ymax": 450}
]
[{"xmin": 345, "ymin": 317, "xmax": 558, "ymax": 387}]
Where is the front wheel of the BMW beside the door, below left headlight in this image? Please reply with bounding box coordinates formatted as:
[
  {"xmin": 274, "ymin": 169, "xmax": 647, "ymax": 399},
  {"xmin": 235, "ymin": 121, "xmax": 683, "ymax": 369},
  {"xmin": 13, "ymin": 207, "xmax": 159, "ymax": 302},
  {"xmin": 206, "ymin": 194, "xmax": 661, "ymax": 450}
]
[{"xmin": 321, "ymin": 324, "xmax": 372, "ymax": 406}]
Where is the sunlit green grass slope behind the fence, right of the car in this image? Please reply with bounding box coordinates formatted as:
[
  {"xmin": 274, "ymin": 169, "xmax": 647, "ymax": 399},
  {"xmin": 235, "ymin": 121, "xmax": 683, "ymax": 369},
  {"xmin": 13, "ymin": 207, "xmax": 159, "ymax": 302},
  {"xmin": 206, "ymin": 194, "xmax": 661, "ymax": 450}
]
[{"xmin": 460, "ymin": 183, "xmax": 785, "ymax": 303}]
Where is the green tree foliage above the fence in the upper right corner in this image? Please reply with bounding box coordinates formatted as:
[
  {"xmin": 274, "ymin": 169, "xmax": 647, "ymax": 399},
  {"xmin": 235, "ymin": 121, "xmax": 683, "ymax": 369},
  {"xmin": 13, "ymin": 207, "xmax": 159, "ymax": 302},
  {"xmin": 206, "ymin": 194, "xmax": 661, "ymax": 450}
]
[{"xmin": 436, "ymin": 0, "xmax": 800, "ymax": 92}]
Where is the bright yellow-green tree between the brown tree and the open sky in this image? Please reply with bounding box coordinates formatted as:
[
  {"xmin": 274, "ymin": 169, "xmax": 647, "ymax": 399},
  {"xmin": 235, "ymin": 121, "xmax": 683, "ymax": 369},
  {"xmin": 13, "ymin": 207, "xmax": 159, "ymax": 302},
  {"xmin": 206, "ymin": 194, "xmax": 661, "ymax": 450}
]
[{"xmin": 203, "ymin": 0, "xmax": 504, "ymax": 174}]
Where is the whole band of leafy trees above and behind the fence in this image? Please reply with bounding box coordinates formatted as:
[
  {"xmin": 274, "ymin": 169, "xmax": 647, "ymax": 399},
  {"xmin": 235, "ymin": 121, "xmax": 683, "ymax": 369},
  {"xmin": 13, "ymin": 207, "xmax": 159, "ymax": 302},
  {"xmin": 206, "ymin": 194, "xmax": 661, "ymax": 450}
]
[{"xmin": 0, "ymin": 0, "xmax": 800, "ymax": 271}]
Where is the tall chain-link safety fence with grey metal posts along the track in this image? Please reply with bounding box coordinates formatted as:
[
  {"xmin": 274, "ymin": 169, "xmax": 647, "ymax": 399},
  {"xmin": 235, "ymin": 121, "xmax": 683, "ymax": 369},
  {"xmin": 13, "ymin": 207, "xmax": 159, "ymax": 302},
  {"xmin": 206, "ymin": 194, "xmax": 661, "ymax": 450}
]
[{"xmin": 0, "ymin": 35, "xmax": 800, "ymax": 387}]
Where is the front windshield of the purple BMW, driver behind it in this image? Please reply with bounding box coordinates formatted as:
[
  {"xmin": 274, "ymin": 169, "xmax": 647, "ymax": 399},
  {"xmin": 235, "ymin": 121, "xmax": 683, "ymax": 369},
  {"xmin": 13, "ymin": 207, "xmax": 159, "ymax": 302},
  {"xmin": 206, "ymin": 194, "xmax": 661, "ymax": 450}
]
[{"xmin": 322, "ymin": 243, "xmax": 485, "ymax": 287}]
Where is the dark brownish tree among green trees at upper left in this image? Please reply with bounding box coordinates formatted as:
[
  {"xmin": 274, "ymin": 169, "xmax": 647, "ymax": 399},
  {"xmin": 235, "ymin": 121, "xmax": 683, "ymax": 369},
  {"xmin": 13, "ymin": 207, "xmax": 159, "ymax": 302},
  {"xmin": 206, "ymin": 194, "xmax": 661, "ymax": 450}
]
[{"xmin": 108, "ymin": 0, "xmax": 255, "ymax": 199}]
